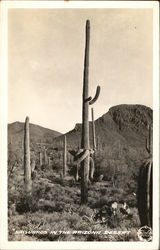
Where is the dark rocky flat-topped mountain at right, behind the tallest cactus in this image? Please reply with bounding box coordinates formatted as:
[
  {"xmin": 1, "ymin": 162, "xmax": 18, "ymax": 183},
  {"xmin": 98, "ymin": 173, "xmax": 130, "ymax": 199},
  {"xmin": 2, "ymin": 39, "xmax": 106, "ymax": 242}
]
[{"xmin": 57, "ymin": 104, "xmax": 153, "ymax": 148}]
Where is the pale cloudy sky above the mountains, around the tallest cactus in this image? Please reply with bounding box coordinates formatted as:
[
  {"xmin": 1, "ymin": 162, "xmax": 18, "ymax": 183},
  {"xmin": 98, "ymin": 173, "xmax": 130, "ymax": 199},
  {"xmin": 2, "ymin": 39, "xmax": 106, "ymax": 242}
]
[{"xmin": 8, "ymin": 8, "xmax": 153, "ymax": 133}]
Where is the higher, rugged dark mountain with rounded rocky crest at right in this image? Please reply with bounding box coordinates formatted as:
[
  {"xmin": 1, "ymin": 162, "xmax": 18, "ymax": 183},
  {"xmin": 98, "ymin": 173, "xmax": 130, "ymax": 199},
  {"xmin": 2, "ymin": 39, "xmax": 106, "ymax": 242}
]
[{"xmin": 60, "ymin": 104, "xmax": 153, "ymax": 147}]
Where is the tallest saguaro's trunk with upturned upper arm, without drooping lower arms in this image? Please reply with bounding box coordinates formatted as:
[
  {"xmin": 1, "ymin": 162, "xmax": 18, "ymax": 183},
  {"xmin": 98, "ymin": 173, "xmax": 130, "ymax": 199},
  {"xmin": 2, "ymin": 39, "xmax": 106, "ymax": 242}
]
[{"xmin": 81, "ymin": 20, "xmax": 100, "ymax": 204}]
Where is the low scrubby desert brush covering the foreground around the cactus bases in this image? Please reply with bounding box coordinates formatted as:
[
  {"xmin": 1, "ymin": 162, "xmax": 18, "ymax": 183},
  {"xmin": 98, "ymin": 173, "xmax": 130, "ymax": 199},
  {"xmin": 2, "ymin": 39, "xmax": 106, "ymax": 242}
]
[{"xmin": 8, "ymin": 145, "xmax": 139, "ymax": 241}]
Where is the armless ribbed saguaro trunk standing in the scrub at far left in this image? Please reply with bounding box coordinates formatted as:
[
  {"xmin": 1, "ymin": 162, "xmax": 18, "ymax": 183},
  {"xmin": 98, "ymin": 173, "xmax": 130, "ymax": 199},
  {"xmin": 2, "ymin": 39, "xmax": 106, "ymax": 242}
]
[{"xmin": 24, "ymin": 117, "xmax": 32, "ymax": 196}]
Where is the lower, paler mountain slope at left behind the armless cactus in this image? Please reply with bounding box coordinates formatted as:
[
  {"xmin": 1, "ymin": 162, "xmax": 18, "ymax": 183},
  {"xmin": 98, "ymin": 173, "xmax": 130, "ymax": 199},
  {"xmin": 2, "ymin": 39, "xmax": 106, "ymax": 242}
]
[{"xmin": 8, "ymin": 122, "xmax": 61, "ymax": 144}]
